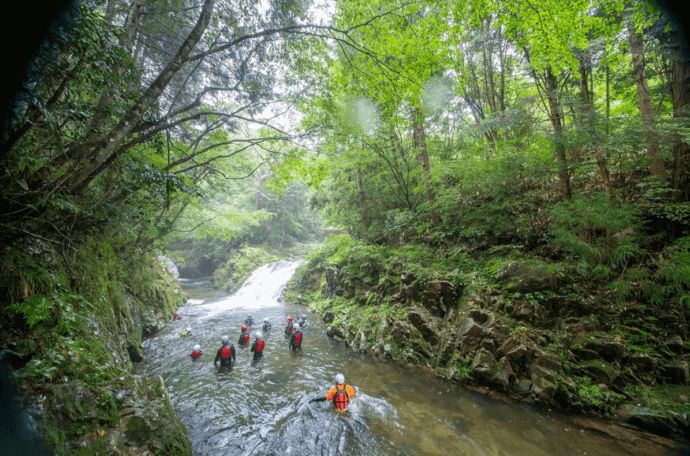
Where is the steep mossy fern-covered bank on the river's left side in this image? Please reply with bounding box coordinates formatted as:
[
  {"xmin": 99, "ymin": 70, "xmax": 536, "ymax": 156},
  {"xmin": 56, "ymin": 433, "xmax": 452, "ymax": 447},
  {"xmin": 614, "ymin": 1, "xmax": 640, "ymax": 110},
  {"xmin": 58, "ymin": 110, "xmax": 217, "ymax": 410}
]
[{"xmin": 0, "ymin": 240, "xmax": 191, "ymax": 455}]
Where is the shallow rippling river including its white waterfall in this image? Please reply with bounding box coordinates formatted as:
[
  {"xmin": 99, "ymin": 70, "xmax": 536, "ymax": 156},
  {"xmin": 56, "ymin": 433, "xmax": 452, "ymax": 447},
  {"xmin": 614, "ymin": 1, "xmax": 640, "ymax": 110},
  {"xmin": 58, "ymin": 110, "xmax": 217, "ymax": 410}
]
[{"xmin": 140, "ymin": 261, "xmax": 676, "ymax": 456}]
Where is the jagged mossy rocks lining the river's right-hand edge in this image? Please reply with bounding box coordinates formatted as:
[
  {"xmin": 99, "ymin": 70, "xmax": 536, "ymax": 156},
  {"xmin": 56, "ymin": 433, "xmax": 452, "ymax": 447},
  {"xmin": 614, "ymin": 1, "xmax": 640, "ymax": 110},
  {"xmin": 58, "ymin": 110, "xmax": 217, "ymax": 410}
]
[{"xmin": 288, "ymin": 263, "xmax": 690, "ymax": 436}]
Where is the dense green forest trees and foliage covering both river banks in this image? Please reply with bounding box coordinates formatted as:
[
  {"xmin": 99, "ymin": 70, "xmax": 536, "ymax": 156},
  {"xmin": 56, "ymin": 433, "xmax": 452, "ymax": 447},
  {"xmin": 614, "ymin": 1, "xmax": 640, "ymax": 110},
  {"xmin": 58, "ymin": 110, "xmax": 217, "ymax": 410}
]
[{"xmin": 0, "ymin": 0, "xmax": 690, "ymax": 446}]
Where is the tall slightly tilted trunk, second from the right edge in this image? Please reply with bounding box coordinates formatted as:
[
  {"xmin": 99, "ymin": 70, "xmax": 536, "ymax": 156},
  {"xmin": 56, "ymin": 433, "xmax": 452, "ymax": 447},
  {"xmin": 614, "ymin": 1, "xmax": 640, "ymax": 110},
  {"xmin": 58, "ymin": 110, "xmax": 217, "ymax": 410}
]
[{"xmin": 628, "ymin": 21, "xmax": 666, "ymax": 176}]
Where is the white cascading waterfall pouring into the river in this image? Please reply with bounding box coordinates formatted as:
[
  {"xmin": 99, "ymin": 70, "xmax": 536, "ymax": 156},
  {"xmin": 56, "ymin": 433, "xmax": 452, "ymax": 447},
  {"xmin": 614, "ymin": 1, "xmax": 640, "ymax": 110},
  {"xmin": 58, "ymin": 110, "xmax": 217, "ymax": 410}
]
[{"xmin": 195, "ymin": 261, "xmax": 302, "ymax": 319}]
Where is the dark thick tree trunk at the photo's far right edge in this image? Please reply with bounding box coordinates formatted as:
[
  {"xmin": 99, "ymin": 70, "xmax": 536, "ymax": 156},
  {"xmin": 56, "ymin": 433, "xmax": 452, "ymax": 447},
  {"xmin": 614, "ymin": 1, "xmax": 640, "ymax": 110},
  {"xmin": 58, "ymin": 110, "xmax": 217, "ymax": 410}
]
[{"xmin": 670, "ymin": 25, "xmax": 690, "ymax": 201}]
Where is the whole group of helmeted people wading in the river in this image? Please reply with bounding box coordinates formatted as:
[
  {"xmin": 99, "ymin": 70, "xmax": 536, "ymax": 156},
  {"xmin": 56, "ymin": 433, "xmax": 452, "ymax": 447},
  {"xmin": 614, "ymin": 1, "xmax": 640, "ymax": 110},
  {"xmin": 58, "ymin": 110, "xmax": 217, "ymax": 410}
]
[{"xmin": 173, "ymin": 312, "xmax": 357, "ymax": 413}]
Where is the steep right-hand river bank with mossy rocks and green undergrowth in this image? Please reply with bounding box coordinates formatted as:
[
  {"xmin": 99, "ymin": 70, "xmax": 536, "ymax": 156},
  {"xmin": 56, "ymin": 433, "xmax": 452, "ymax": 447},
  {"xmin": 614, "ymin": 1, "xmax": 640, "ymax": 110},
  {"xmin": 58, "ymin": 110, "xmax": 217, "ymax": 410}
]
[{"xmin": 287, "ymin": 237, "xmax": 690, "ymax": 436}]
